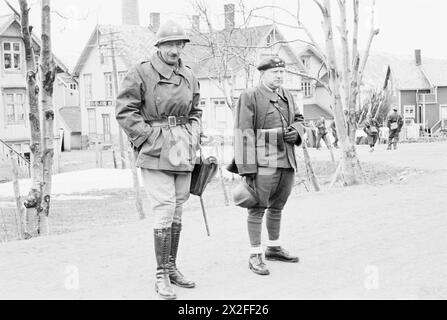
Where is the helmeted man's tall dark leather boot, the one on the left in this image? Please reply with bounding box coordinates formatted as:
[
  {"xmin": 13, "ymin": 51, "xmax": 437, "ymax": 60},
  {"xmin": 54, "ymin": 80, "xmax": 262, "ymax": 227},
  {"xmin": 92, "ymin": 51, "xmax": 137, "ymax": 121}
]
[{"xmin": 154, "ymin": 228, "xmax": 177, "ymax": 300}]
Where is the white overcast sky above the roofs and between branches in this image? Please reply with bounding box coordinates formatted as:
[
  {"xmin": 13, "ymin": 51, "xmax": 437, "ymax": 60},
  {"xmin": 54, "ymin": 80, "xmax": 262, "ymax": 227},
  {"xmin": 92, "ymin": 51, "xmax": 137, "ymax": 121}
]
[{"xmin": 0, "ymin": 0, "xmax": 447, "ymax": 68}]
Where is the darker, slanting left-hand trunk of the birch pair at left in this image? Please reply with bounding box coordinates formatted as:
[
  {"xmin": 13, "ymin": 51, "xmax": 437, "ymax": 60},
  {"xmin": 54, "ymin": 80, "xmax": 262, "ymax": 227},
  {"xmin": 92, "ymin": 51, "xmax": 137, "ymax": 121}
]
[{"xmin": 19, "ymin": 0, "xmax": 43, "ymax": 236}]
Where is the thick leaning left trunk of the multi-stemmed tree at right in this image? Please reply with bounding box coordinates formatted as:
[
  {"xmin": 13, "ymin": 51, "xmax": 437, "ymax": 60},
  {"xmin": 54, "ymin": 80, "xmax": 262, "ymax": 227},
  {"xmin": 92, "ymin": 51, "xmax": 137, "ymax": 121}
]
[{"xmin": 316, "ymin": 0, "xmax": 360, "ymax": 185}]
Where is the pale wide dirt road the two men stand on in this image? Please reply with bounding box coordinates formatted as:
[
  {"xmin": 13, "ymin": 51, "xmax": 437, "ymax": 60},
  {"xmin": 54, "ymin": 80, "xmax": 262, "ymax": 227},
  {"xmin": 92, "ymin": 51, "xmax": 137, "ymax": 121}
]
[{"xmin": 0, "ymin": 143, "xmax": 447, "ymax": 299}]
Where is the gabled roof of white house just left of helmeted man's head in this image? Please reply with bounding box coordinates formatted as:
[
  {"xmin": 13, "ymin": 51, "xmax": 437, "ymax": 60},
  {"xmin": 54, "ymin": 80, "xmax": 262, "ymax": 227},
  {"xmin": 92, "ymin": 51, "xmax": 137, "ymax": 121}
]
[{"xmin": 73, "ymin": 25, "xmax": 155, "ymax": 76}]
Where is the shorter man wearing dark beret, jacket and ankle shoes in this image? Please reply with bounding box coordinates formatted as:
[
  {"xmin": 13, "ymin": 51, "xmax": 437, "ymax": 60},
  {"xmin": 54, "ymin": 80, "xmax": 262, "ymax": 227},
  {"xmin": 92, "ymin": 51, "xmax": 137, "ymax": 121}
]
[{"xmin": 234, "ymin": 56, "xmax": 304, "ymax": 275}]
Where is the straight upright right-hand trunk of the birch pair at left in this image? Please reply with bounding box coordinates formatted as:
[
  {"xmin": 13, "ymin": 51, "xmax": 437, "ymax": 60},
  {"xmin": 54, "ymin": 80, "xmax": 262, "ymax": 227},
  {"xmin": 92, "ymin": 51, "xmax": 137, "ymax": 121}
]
[{"xmin": 39, "ymin": 0, "xmax": 56, "ymax": 235}]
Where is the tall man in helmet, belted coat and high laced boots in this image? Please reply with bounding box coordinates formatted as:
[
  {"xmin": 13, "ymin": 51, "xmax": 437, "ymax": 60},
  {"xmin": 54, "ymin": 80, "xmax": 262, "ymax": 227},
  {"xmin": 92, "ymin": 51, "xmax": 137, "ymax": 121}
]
[{"xmin": 116, "ymin": 21, "xmax": 202, "ymax": 299}]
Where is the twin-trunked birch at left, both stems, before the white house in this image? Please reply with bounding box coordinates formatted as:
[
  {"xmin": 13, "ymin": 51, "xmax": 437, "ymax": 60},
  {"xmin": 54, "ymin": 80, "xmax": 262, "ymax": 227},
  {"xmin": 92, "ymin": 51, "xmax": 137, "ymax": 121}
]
[{"xmin": 19, "ymin": 0, "xmax": 56, "ymax": 235}]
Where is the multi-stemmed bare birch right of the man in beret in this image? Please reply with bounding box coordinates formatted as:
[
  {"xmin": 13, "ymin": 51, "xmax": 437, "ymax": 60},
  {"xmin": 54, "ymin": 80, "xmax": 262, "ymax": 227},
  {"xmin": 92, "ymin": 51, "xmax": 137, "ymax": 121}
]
[{"xmin": 250, "ymin": 0, "xmax": 379, "ymax": 185}]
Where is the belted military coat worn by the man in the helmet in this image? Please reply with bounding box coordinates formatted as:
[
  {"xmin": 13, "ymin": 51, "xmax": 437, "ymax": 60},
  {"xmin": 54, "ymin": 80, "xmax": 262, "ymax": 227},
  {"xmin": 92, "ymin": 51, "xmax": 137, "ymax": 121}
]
[{"xmin": 116, "ymin": 53, "xmax": 202, "ymax": 172}]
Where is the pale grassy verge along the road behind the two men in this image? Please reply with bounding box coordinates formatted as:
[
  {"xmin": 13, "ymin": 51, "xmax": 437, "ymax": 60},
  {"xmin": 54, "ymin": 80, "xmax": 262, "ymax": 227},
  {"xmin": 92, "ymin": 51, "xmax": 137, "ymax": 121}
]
[{"xmin": 0, "ymin": 158, "xmax": 408, "ymax": 240}]
